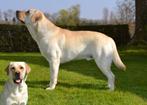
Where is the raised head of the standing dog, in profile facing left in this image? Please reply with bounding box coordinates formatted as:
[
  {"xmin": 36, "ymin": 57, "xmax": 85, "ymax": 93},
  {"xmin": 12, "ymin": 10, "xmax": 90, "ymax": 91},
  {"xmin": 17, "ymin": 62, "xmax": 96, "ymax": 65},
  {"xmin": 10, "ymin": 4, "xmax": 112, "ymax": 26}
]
[{"xmin": 16, "ymin": 9, "xmax": 44, "ymax": 24}]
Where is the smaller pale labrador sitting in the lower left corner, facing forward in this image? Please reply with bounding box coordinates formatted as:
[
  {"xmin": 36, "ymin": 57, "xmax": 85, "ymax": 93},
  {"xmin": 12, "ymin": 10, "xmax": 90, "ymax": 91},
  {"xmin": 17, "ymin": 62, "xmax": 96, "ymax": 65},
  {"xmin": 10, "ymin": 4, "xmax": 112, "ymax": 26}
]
[{"xmin": 0, "ymin": 62, "xmax": 30, "ymax": 105}]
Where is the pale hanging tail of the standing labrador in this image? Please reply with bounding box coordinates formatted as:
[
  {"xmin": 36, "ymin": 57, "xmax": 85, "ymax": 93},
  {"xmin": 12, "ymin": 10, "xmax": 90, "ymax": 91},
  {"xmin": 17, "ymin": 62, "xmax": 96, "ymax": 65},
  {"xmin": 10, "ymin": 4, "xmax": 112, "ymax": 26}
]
[{"xmin": 113, "ymin": 41, "xmax": 126, "ymax": 70}]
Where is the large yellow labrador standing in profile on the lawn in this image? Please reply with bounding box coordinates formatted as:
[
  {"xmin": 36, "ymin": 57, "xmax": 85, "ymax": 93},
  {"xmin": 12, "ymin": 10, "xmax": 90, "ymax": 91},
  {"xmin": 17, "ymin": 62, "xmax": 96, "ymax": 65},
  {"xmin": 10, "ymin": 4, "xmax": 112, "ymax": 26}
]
[{"xmin": 16, "ymin": 9, "xmax": 126, "ymax": 90}]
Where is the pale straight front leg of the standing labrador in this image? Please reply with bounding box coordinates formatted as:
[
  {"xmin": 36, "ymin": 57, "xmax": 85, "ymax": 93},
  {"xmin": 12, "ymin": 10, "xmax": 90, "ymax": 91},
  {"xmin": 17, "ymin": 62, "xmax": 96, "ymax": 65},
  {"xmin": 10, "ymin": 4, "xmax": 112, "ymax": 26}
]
[{"xmin": 46, "ymin": 59, "xmax": 60, "ymax": 90}]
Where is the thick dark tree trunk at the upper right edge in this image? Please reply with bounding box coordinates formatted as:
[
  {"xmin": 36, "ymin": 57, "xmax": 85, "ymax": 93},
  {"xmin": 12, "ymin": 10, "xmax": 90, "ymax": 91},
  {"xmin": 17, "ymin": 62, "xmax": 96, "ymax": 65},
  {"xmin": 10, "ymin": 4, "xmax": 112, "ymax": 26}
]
[{"xmin": 133, "ymin": 0, "xmax": 147, "ymax": 42}]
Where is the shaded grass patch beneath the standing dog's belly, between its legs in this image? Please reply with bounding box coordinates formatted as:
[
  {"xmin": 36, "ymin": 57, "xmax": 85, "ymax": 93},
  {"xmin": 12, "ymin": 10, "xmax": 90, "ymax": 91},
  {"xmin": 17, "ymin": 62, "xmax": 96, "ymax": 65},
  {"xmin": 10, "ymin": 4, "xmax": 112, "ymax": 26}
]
[{"xmin": 60, "ymin": 60, "xmax": 105, "ymax": 79}]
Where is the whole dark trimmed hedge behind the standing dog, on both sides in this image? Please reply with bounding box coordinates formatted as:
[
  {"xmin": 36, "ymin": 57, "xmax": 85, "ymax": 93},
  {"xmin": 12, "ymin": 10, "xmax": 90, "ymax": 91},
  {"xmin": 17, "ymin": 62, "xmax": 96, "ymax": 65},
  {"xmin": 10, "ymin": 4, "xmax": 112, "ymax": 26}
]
[{"xmin": 0, "ymin": 24, "xmax": 130, "ymax": 52}]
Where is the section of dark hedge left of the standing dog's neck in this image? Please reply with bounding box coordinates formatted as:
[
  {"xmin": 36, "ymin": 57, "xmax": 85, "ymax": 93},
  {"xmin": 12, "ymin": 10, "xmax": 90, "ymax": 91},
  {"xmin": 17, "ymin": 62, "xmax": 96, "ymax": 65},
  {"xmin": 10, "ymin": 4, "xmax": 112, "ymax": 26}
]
[{"xmin": 0, "ymin": 24, "xmax": 39, "ymax": 52}]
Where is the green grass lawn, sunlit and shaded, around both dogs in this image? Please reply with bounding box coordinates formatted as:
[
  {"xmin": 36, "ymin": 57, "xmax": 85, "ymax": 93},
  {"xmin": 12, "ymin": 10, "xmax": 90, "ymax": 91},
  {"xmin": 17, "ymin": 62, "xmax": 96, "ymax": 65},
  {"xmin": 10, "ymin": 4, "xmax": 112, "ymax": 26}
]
[{"xmin": 0, "ymin": 50, "xmax": 147, "ymax": 105}]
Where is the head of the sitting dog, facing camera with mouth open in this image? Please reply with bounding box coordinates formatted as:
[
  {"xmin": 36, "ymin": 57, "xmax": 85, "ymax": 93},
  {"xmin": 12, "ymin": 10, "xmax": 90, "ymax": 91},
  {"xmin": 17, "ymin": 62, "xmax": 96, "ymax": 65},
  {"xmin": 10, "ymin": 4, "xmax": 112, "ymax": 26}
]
[{"xmin": 6, "ymin": 62, "xmax": 31, "ymax": 84}]
